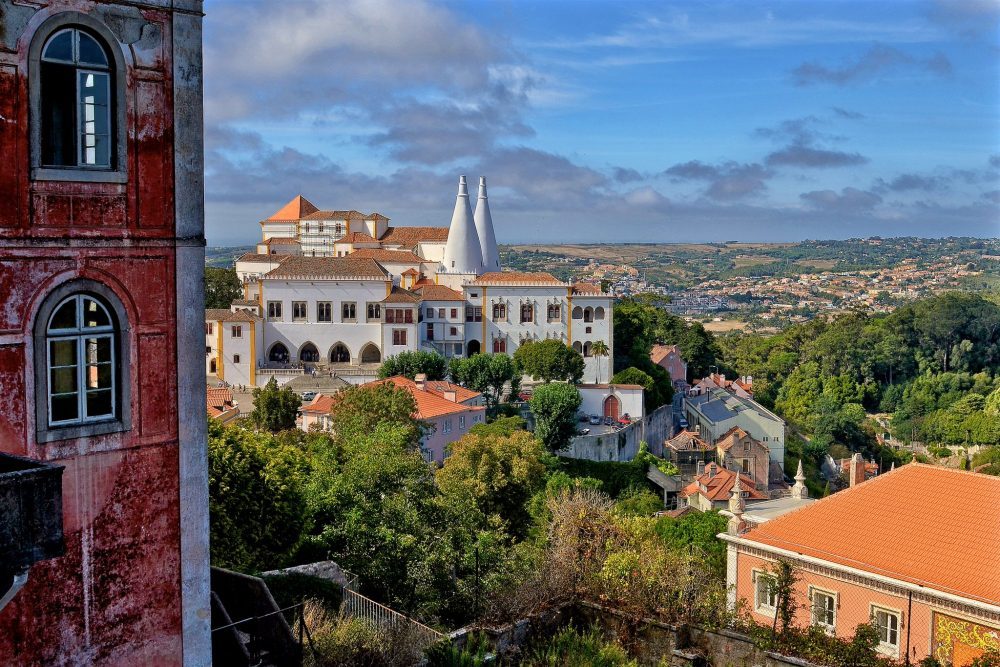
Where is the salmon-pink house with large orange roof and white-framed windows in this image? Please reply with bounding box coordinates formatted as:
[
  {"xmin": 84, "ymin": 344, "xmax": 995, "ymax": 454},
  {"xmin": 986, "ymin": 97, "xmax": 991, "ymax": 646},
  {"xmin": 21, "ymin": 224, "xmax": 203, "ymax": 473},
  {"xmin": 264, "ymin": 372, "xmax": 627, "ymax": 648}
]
[{"xmin": 719, "ymin": 463, "xmax": 1000, "ymax": 667}]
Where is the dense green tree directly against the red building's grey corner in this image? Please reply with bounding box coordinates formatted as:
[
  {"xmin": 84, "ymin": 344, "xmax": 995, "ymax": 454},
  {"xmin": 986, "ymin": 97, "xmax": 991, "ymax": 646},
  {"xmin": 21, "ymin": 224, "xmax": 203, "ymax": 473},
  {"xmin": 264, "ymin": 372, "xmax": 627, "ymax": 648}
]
[{"xmin": 208, "ymin": 419, "xmax": 309, "ymax": 572}]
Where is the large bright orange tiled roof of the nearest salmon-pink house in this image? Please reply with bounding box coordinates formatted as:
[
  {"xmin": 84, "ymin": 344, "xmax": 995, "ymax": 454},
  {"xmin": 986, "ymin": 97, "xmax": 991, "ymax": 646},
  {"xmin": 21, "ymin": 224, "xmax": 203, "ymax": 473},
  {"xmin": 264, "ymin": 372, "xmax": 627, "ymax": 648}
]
[{"xmin": 743, "ymin": 463, "xmax": 1000, "ymax": 604}]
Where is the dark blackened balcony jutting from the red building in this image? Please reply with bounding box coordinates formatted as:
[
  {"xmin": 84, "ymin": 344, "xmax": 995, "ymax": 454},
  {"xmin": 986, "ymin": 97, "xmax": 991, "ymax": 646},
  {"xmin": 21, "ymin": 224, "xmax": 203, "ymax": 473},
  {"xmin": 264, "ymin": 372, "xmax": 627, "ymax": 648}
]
[{"xmin": 0, "ymin": 454, "xmax": 65, "ymax": 609}]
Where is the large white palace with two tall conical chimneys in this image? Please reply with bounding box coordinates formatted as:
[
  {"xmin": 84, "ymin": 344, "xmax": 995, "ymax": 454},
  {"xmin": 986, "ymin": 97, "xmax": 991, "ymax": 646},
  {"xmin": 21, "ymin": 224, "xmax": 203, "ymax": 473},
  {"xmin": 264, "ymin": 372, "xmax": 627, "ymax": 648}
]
[{"xmin": 205, "ymin": 176, "xmax": 614, "ymax": 386}]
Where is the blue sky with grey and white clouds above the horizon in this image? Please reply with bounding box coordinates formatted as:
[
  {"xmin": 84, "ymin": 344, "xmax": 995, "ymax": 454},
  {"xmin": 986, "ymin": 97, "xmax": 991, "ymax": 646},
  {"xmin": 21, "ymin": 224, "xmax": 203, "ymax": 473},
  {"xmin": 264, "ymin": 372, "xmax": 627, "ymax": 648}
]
[{"xmin": 199, "ymin": 0, "xmax": 1000, "ymax": 245}]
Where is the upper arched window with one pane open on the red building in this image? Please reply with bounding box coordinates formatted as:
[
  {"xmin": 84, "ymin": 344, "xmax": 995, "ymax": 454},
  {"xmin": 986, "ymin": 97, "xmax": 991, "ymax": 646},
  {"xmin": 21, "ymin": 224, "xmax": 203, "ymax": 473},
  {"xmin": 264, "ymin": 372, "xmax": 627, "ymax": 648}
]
[{"xmin": 39, "ymin": 26, "xmax": 117, "ymax": 169}]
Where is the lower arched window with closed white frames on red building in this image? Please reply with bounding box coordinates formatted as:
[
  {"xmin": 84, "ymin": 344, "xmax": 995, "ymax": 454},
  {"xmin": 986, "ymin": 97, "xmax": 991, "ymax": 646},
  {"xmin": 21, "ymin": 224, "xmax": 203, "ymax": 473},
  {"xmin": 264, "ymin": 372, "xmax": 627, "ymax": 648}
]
[{"xmin": 45, "ymin": 294, "xmax": 119, "ymax": 427}]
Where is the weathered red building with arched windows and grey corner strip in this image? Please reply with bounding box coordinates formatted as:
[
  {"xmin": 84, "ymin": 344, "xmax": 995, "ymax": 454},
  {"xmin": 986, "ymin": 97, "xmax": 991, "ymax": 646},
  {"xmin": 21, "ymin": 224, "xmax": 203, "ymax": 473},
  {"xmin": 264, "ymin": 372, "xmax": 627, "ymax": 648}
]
[{"xmin": 0, "ymin": 0, "xmax": 211, "ymax": 665}]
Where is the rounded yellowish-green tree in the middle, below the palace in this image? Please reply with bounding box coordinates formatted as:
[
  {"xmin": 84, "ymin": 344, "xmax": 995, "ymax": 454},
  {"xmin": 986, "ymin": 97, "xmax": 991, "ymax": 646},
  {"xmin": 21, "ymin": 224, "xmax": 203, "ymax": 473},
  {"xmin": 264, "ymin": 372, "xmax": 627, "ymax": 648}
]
[{"xmin": 435, "ymin": 430, "xmax": 546, "ymax": 539}]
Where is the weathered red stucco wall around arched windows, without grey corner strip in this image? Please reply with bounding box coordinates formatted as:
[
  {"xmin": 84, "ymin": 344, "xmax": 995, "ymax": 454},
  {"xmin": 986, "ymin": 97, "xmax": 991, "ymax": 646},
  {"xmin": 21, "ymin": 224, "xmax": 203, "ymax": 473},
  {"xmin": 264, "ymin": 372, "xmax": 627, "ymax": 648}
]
[{"xmin": 0, "ymin": 0, "xmax": 187, "ymax": 665}]
